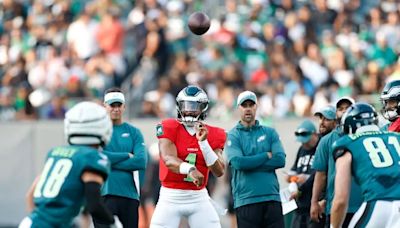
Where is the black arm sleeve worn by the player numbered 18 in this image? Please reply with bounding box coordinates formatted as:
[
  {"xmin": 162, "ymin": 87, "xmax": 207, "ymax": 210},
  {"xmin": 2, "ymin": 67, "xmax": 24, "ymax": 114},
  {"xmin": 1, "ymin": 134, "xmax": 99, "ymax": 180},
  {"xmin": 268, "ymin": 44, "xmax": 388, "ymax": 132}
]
[{"xmin": 85, "ymin": 182, "xmax": 114, "ymax": 225}]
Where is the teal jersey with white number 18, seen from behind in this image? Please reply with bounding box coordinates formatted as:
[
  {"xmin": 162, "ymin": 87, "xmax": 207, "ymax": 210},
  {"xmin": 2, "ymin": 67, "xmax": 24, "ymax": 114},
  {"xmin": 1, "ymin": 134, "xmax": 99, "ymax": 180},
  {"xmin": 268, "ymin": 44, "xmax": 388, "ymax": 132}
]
[{"xmin": 30, "ymin": 146, "xmax": 110, "ymax": 228}]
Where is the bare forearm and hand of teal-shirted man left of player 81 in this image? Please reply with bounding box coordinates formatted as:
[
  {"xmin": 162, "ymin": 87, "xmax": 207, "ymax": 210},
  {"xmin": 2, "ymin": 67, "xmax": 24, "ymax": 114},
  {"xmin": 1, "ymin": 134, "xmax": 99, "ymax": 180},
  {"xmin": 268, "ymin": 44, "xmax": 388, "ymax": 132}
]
[{"xmin": 310, "ymin": 171, "xmax": 326, "ymax": 222}]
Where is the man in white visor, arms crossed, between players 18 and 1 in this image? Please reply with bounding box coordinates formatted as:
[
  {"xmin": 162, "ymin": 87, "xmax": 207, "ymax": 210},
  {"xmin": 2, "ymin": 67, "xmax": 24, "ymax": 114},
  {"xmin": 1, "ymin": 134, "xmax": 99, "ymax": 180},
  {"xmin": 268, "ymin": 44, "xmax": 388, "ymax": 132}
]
[{"xmin": 94, "ymin": 88, "xmax": 147, "ymax": 228}]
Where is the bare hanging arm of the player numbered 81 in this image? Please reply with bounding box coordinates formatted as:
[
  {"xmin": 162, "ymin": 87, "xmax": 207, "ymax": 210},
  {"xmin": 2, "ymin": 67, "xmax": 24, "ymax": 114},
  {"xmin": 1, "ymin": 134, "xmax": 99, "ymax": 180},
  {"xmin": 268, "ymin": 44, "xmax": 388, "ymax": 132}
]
[{"xmin": 331, "ymin": 153, "xmax": 352, "ymax": 228}]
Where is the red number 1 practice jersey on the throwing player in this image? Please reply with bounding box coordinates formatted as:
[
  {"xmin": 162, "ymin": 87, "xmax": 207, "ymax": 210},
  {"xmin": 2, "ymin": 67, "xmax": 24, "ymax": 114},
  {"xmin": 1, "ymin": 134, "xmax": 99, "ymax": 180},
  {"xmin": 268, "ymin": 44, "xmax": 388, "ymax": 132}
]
[{"xmin": 157, "ymin": 119, "xmax": 226, "ymax": 190}]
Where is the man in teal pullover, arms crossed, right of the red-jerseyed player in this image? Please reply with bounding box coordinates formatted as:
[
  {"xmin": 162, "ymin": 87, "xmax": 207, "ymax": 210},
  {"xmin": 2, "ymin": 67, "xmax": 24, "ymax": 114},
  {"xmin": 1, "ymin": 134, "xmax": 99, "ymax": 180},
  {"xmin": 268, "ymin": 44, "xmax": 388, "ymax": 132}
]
[{"xmin": 225, "ymin": 91, "xmax": 285, "ymax": 228}]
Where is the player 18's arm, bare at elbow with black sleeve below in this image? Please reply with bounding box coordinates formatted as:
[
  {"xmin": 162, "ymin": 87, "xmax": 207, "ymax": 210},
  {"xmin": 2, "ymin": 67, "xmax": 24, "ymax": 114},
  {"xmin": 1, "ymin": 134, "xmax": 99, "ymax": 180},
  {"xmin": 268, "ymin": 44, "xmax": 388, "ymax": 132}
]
[{"xmin": 81, "ymin": 171, "xmax": 114, "ymax": 224}]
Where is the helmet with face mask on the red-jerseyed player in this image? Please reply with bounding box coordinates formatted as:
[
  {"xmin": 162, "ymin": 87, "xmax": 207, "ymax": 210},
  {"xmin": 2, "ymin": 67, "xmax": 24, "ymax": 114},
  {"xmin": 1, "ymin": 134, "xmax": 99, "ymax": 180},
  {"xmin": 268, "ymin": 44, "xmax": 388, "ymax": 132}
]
[{"xmin": 176, "ymin": 85, "xmax": 209, "ymax": 126}]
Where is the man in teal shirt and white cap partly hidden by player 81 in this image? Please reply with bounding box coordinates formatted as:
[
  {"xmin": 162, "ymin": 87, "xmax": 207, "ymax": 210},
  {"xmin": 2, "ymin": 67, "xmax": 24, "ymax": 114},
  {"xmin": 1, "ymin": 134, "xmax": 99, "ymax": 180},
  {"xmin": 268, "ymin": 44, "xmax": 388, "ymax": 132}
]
[{"xmin": 311, "ymin": 97, "xmax": 362, "ymax": 227}]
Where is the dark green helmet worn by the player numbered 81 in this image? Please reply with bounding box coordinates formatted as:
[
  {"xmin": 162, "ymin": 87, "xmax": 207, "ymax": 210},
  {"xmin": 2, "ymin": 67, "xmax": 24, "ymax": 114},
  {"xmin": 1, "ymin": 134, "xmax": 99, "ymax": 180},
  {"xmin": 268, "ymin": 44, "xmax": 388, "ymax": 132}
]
[{"xmin": 341, "ymin": 102, "xmax": 378, "ymax": 134}]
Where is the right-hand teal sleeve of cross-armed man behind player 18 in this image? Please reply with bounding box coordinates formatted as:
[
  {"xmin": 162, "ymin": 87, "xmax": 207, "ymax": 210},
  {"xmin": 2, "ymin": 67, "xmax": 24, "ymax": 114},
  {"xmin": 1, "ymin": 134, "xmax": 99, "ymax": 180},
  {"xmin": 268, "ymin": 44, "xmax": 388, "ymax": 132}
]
[{"xmin": 112, "ymin": 129, "xmax": 147, "ymax": 171}]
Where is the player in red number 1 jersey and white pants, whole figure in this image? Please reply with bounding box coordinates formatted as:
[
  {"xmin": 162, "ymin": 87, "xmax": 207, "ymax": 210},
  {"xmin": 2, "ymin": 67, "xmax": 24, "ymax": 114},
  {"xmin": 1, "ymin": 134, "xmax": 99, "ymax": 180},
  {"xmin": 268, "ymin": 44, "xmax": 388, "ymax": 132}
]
[{"xmin": 150, "ymin": 86, "xmax": 226, "ymax": 228}]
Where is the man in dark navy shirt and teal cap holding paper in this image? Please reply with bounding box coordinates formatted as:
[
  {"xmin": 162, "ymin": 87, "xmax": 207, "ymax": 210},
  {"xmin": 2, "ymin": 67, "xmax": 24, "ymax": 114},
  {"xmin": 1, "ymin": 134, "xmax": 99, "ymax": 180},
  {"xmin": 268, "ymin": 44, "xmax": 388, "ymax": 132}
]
[{"xmin": 286, "ymin": 120, "xmax": 319, "ymax": 228}]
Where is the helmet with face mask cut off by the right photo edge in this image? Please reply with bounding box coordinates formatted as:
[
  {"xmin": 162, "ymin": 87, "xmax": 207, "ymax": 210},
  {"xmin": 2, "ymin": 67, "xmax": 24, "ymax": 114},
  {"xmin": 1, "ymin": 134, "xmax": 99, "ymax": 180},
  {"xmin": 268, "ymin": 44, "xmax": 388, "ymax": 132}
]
[{"xmin": 381, "ymin": 80, "xmax": 400, "ymax": 122}]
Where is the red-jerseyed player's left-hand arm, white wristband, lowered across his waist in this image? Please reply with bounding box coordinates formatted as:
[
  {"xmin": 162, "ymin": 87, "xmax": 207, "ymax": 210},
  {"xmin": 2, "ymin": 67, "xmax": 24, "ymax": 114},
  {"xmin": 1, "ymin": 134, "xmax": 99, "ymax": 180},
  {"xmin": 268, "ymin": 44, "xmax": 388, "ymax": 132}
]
[{"xmin": 158, "ymin": 138, "xmax": 204, "ymax": 186}]
